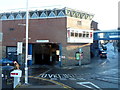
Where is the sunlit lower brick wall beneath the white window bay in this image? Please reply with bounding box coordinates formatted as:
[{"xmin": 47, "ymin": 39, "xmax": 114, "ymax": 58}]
[{"xmin": 62, "ymin": 44, "xmax": 90, "ymax": 66}]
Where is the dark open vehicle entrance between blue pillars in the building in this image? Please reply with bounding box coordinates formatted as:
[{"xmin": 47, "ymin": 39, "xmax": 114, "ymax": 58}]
[{"xmin": 33, "ymin": 43, "xmax": 59, "ymax": 65}]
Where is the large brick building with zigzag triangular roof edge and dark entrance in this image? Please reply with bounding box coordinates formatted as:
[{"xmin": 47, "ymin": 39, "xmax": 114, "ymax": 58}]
[{"xmin": 0, "ymin": 8, "xmax": 94, "ymax": 66}]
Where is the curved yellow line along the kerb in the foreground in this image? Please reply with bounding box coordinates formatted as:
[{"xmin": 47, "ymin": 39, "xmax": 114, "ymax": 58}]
[{"xmin": 29, "ymin": 76, "xmax": 75, "ymax": 90}]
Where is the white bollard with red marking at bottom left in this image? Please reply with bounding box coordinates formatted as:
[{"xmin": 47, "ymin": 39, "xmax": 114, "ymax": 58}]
[{"xmin": 10, "ymin": 70, "xmax": 22, "ymax": 88}]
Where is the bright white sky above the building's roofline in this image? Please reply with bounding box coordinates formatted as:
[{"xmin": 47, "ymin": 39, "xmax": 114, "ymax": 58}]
[{"xmin": 0, "ymin": 0, "xmax": 119, "ymax": 30}]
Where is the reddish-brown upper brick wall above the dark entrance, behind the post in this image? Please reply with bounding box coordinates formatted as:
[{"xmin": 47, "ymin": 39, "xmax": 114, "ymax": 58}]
[{"xmin": 3, "ymin": 18, "xmax": 67, "ymax": 46}]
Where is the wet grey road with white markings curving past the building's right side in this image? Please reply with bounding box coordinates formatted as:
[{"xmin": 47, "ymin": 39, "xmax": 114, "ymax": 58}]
[{"xmin": 39, "ymin": 43, "xmax": 120, "ymax": 90}]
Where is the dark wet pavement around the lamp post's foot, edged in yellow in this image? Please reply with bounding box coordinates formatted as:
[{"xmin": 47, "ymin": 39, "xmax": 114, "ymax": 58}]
[{"xmin": 15, "ymin": 65, "xmax": 72, "ymax": 90}]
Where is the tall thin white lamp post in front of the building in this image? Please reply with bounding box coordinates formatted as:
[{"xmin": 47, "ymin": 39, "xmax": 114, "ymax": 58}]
[{"xmin": 25, "ymin": 0, "xmax": 29, "ymax": 84}]
